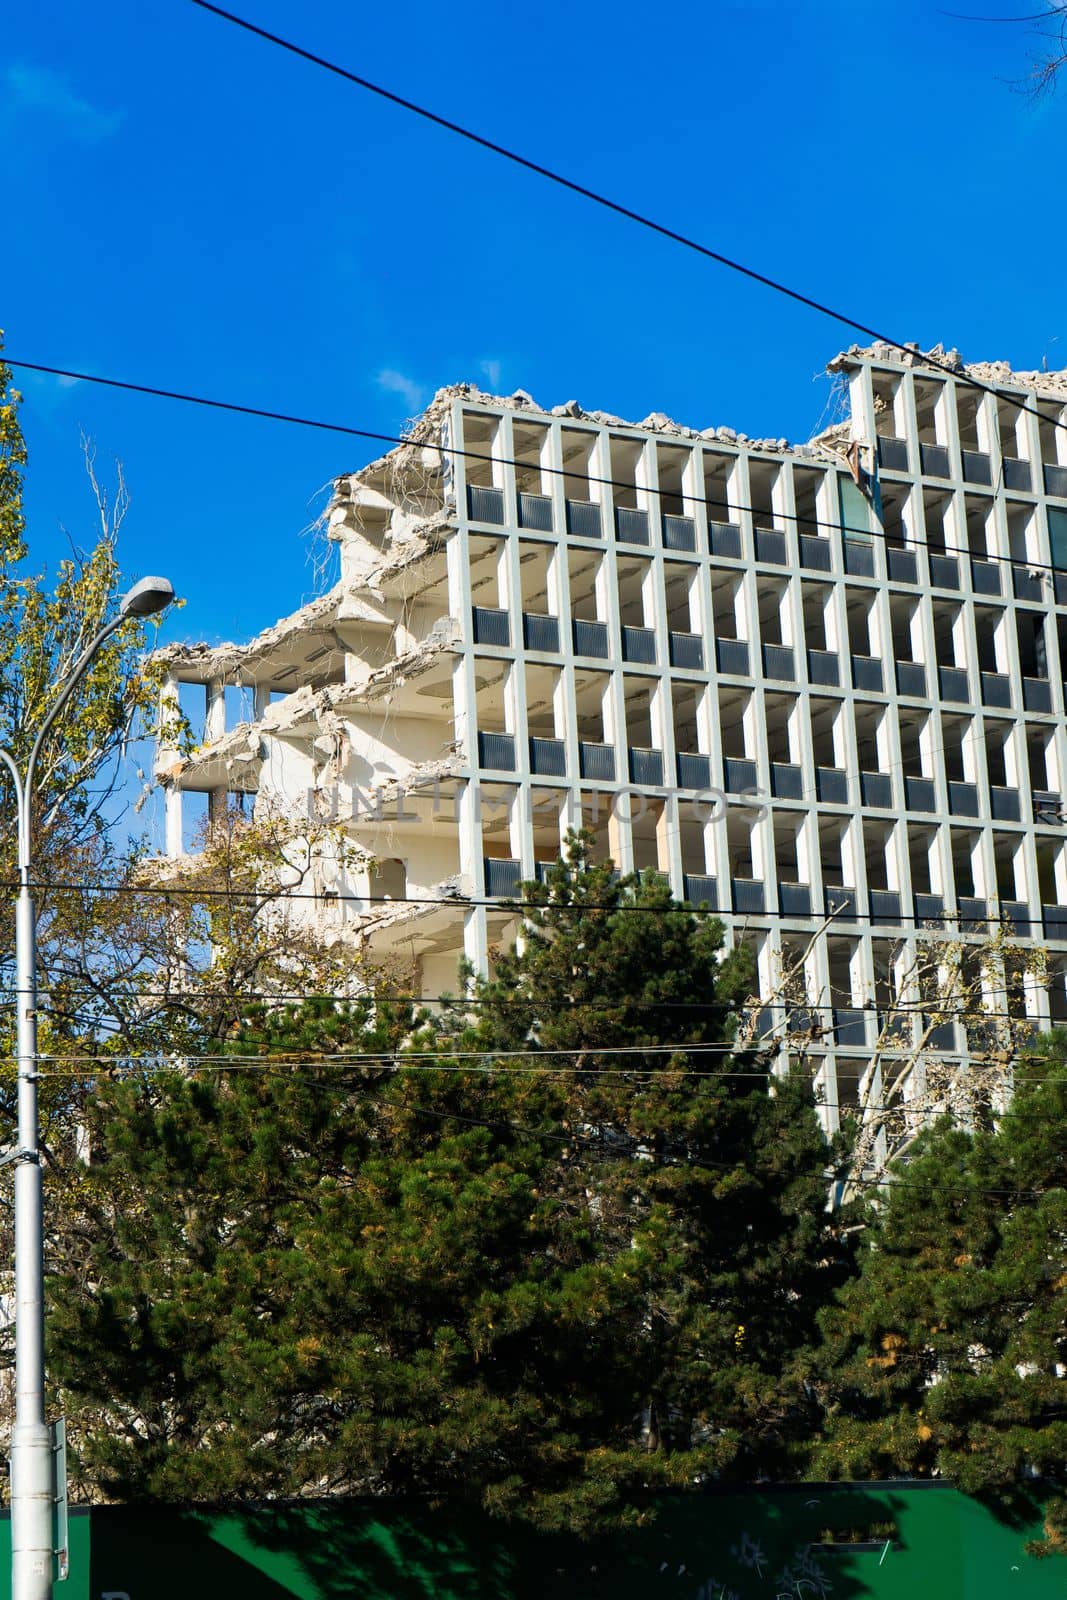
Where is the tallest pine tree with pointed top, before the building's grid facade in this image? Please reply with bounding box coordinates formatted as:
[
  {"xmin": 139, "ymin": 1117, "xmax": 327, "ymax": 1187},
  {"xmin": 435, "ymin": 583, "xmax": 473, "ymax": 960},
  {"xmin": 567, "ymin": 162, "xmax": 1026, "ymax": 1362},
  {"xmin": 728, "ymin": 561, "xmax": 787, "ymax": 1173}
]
[{"xmin": 454, "ymin": 838, "xmax": 846, "ymax": 1478}]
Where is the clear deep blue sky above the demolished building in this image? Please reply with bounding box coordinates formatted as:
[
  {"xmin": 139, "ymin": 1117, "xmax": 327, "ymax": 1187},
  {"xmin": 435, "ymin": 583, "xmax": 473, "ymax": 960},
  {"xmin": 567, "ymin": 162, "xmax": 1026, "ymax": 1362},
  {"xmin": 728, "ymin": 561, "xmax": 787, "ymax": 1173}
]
[{"xmin": 0, "ymin": 0, "xmax": 1067, "ymax": 662}]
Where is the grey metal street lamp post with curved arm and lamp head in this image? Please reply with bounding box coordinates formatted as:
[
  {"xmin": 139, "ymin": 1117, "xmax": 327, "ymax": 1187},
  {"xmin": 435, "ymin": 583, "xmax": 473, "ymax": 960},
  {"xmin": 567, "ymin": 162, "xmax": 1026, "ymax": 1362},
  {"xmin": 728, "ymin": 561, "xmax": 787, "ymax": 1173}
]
[{"xmin": 0, "ymin": 578, "xmax": 174, "ymax": 1600}]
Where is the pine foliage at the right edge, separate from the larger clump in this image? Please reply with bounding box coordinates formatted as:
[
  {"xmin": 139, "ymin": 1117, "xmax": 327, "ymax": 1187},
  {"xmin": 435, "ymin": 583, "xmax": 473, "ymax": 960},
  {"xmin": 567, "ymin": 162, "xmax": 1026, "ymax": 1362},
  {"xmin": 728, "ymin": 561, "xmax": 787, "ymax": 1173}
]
[{"xmin": 813, "ymin": 1032, "xmax": 1067, "ymax": 1550}]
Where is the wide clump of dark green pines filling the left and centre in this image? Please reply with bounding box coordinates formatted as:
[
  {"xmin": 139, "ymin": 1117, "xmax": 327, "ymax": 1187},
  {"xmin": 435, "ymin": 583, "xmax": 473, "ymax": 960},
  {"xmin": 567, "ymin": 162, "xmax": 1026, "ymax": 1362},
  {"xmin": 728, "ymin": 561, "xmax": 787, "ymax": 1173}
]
[{"xmin": 50, "ymin": 840, "xmax": 843, "ymax": 1528}]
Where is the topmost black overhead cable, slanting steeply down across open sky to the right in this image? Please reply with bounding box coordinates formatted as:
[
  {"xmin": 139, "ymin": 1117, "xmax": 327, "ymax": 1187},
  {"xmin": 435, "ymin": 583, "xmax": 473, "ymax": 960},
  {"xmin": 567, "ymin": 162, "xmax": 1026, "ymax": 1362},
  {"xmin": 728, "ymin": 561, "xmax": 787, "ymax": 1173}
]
[{"xmin": 183, "ymin": 0, "xmax": 1067, "ymax": 457}]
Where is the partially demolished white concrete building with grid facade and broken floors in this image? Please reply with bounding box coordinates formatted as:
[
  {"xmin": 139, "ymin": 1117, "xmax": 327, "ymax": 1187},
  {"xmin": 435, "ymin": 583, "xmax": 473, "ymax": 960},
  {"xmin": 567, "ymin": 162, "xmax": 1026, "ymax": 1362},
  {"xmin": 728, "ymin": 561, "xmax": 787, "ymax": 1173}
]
[{"xmin": 151, "ymin": 346, "xmax": 1067, "ymax": 1122}]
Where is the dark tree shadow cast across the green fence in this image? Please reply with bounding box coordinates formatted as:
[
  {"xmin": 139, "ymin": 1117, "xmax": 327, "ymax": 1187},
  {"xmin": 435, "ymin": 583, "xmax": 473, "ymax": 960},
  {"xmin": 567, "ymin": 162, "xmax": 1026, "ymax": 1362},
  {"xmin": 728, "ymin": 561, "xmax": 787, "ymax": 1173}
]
[{"xmin": 93, "ymin": 1486, "xmax": 921, "ymax": 1600}]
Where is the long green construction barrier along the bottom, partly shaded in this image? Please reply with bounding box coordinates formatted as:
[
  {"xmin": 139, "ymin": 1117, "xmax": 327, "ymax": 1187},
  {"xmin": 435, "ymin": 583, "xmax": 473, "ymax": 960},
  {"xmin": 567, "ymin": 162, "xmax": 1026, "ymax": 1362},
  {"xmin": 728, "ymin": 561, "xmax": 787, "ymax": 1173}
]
[{"xmin": 0, "ymin": 1483, "xmax": 1067, "ymax": 1600}]
